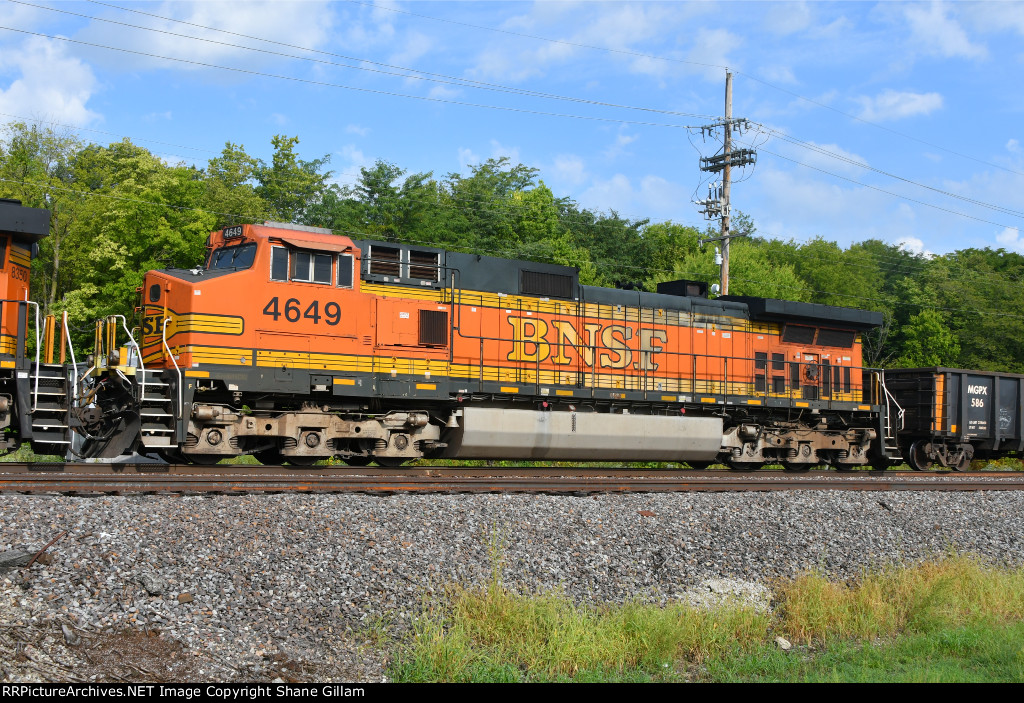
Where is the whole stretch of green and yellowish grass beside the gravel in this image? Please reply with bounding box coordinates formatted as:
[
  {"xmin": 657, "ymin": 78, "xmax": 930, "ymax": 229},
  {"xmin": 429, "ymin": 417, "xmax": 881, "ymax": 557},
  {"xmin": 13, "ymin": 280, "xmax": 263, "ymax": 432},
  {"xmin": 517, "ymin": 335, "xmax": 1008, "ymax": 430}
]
[{"xmin": 391, "ymin": 556, "xmax": 1024, "ymax": 682}]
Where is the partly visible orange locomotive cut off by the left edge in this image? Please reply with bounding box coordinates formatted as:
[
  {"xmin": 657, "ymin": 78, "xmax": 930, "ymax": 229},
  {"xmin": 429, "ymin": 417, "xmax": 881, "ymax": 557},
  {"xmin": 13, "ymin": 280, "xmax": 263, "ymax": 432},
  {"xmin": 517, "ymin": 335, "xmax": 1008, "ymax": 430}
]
[{"xmin": 0, "ymin": 199, "xmax": 71, "ymax": 456}]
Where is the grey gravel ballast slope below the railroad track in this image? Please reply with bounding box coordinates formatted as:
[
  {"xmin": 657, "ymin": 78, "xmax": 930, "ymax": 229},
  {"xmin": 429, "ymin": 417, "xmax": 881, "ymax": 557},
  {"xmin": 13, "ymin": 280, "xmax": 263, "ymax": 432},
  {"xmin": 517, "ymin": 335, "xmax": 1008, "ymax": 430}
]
[{"xmin": 0, "ymin": 491, "xmax": 1024, "ymax": 680}]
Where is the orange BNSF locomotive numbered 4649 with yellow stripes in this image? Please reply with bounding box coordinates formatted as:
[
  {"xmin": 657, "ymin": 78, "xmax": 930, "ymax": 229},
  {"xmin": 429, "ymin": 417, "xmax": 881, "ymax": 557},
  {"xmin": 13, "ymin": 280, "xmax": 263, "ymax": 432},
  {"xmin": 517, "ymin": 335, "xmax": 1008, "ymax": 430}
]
[{"xmin": 77, "ymin": 223, "xmax": 901, "ymax": 470}]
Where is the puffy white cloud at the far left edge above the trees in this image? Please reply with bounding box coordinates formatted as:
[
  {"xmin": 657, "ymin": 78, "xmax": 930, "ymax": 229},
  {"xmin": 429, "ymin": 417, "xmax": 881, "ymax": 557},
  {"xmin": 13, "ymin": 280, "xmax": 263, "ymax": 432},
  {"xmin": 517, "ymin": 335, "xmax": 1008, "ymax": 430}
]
[{"xmin": 0, "ymin": 37, "xmax": 100, "ymax": 125}]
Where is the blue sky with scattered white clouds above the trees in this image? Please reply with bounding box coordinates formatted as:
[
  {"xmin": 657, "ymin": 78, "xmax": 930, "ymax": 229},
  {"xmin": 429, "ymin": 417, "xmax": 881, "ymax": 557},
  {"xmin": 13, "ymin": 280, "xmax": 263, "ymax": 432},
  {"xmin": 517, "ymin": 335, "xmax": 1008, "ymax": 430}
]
[{"xmin": 0, "ymin": 0, "xmax": 1024, "ymax": 253}]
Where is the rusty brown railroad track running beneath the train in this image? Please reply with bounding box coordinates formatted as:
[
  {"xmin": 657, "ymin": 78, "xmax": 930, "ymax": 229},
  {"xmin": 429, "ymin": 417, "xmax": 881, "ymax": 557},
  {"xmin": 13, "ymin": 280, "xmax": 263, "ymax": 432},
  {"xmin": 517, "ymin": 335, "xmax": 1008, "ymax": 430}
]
[{"xmin": 0, "ymin": 464, "xmax": 1024, "ymax": 495}]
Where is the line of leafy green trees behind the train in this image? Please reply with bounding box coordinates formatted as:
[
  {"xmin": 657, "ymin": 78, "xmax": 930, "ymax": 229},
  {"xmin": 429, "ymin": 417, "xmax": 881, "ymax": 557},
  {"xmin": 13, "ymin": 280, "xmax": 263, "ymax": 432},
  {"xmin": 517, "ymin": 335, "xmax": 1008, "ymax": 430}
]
[{"xmin": 0, "ymin": 122, "xmax": 1024, "ymax": 372}]
